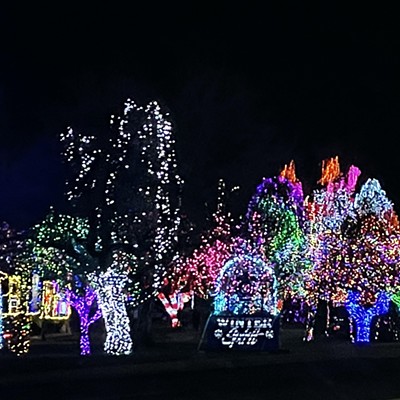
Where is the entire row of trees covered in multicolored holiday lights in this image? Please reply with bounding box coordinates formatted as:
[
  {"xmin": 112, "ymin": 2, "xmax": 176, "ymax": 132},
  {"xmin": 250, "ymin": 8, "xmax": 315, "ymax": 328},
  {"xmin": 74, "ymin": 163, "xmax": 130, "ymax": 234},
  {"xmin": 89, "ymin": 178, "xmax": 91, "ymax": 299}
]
[{"xmin": 4, "ymin": 107, "xmax": 400, "ymax": 355}]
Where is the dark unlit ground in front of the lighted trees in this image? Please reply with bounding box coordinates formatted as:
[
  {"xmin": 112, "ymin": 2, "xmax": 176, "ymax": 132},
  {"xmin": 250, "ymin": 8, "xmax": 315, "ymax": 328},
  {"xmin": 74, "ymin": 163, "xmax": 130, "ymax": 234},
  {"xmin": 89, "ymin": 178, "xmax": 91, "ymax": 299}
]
[{"xmin": 0, "ymin": 320, "xmax": 400, "ymax": 400}]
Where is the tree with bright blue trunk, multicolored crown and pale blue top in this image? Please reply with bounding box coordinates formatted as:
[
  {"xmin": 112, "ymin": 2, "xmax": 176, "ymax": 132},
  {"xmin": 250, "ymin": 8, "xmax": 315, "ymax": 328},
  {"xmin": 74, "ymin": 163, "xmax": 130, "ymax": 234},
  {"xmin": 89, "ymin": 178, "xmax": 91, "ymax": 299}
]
[{"xmin": 344, "ymin": 179, "xmax": 400, "ymax": 342}]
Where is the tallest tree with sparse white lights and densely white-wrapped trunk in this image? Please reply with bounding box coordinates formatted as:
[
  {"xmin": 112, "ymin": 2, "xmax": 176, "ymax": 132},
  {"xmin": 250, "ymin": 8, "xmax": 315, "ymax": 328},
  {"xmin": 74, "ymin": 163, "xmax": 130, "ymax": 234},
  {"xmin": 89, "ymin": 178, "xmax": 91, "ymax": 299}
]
[{"xmin": 60, "ymin": 99, "xmax": 182, "ymax": 354}]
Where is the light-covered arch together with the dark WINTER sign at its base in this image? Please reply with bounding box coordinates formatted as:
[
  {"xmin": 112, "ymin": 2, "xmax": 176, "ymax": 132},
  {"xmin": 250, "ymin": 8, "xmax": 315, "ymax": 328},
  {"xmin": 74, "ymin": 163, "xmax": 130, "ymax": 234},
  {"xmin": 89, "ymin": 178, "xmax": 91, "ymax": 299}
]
[{"xmin": 199, "ymin": 253, "xmax": 279, "ymax": 351}]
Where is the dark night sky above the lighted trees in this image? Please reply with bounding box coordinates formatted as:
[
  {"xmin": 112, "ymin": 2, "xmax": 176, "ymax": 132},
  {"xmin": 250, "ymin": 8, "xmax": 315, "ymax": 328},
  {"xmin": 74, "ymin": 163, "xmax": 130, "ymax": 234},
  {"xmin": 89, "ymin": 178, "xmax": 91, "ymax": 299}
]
[{"xmin": 0, "ymin": 1, "xmax": 400, "ymax": 229}]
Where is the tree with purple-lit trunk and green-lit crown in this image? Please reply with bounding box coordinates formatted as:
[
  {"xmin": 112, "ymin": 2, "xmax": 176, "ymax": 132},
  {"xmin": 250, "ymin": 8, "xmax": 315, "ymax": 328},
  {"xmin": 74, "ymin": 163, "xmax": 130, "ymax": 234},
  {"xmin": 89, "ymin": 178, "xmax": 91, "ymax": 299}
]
[{"xmin": 23, "ymin": 209, "xmax": 101, "ymax": 355}]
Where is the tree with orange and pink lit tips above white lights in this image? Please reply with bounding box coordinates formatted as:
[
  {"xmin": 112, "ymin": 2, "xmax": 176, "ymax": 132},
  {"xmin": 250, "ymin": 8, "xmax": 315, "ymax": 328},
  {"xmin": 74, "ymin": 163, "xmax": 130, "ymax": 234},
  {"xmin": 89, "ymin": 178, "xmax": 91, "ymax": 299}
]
[{"xmin": 303, "ymin": 157, "xmax": 361, "ymax": 340}]
